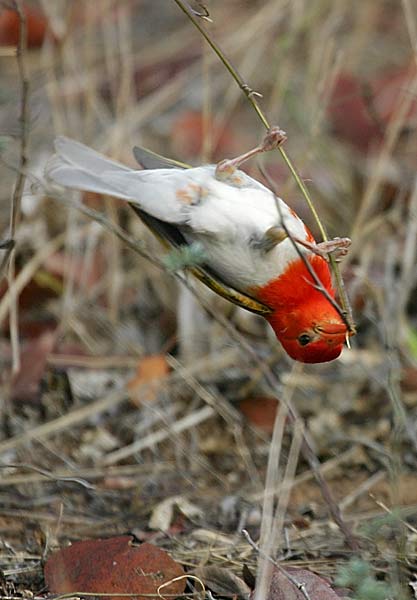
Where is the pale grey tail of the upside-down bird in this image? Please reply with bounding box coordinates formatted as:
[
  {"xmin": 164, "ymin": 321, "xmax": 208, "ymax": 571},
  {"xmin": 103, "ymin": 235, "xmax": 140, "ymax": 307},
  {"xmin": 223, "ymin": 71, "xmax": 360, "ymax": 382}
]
[{"xmin": 45, "ymin": 136, "xmax": 136, "ymax": 200}]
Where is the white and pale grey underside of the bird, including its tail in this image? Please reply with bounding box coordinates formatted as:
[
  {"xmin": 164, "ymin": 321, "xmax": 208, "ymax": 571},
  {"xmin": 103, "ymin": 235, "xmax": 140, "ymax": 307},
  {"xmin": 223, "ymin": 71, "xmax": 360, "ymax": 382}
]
[{"xmin": 46, "ymin": 137, "xmax": 308, "ymax": 291}]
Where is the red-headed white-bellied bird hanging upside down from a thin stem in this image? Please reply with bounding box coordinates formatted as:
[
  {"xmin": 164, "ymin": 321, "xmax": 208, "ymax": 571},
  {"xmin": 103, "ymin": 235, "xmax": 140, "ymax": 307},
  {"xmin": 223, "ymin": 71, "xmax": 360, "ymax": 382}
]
[{"xmin": 45, "ymin": 127, "xmax": 352, "ymax": 363}]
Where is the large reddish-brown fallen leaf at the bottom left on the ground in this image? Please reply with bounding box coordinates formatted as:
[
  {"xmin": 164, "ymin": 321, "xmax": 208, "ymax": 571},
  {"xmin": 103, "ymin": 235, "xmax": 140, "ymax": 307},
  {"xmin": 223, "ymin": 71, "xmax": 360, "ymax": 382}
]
[{"xmin": 45, "ymin": 535, "xmax": 186, "ymax": 600}]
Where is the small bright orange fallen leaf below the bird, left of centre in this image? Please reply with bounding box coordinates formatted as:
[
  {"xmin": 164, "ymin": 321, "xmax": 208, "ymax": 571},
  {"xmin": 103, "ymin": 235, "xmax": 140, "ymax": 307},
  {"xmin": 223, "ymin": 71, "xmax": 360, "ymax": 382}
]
[{"xmin": 127, "ymin": 354, "xmax": 169, "ymax": 406}]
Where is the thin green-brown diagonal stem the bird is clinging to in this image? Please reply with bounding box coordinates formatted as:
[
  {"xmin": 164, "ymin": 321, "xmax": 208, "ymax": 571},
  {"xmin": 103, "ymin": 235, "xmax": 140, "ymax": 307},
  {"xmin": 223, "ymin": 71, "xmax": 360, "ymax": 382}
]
[{"xmin": 174, "ymin": 0, "xmax": 356, "ymax": 334}]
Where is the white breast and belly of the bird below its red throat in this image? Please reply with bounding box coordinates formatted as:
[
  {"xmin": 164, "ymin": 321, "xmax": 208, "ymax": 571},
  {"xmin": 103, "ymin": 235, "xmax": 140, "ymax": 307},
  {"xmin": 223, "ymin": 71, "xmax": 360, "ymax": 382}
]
[{"xmin": 180, "ymin": 179, "xmax": 307, "ymax": 290}]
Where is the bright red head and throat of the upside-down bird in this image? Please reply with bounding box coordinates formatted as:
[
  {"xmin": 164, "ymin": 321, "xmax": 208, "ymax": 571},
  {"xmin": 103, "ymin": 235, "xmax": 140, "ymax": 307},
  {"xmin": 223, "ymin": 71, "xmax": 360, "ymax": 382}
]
[{"xmin": 257, "ymin": 256, "xmax": 348, "ymax": 363}]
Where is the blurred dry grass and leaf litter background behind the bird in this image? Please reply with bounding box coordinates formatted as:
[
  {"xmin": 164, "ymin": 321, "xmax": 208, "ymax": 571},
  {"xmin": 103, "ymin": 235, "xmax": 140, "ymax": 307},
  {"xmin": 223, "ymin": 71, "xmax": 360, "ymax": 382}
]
[{"xmin": 0, "ymin": 0, "xmax": 417, "ymax": 599}]
